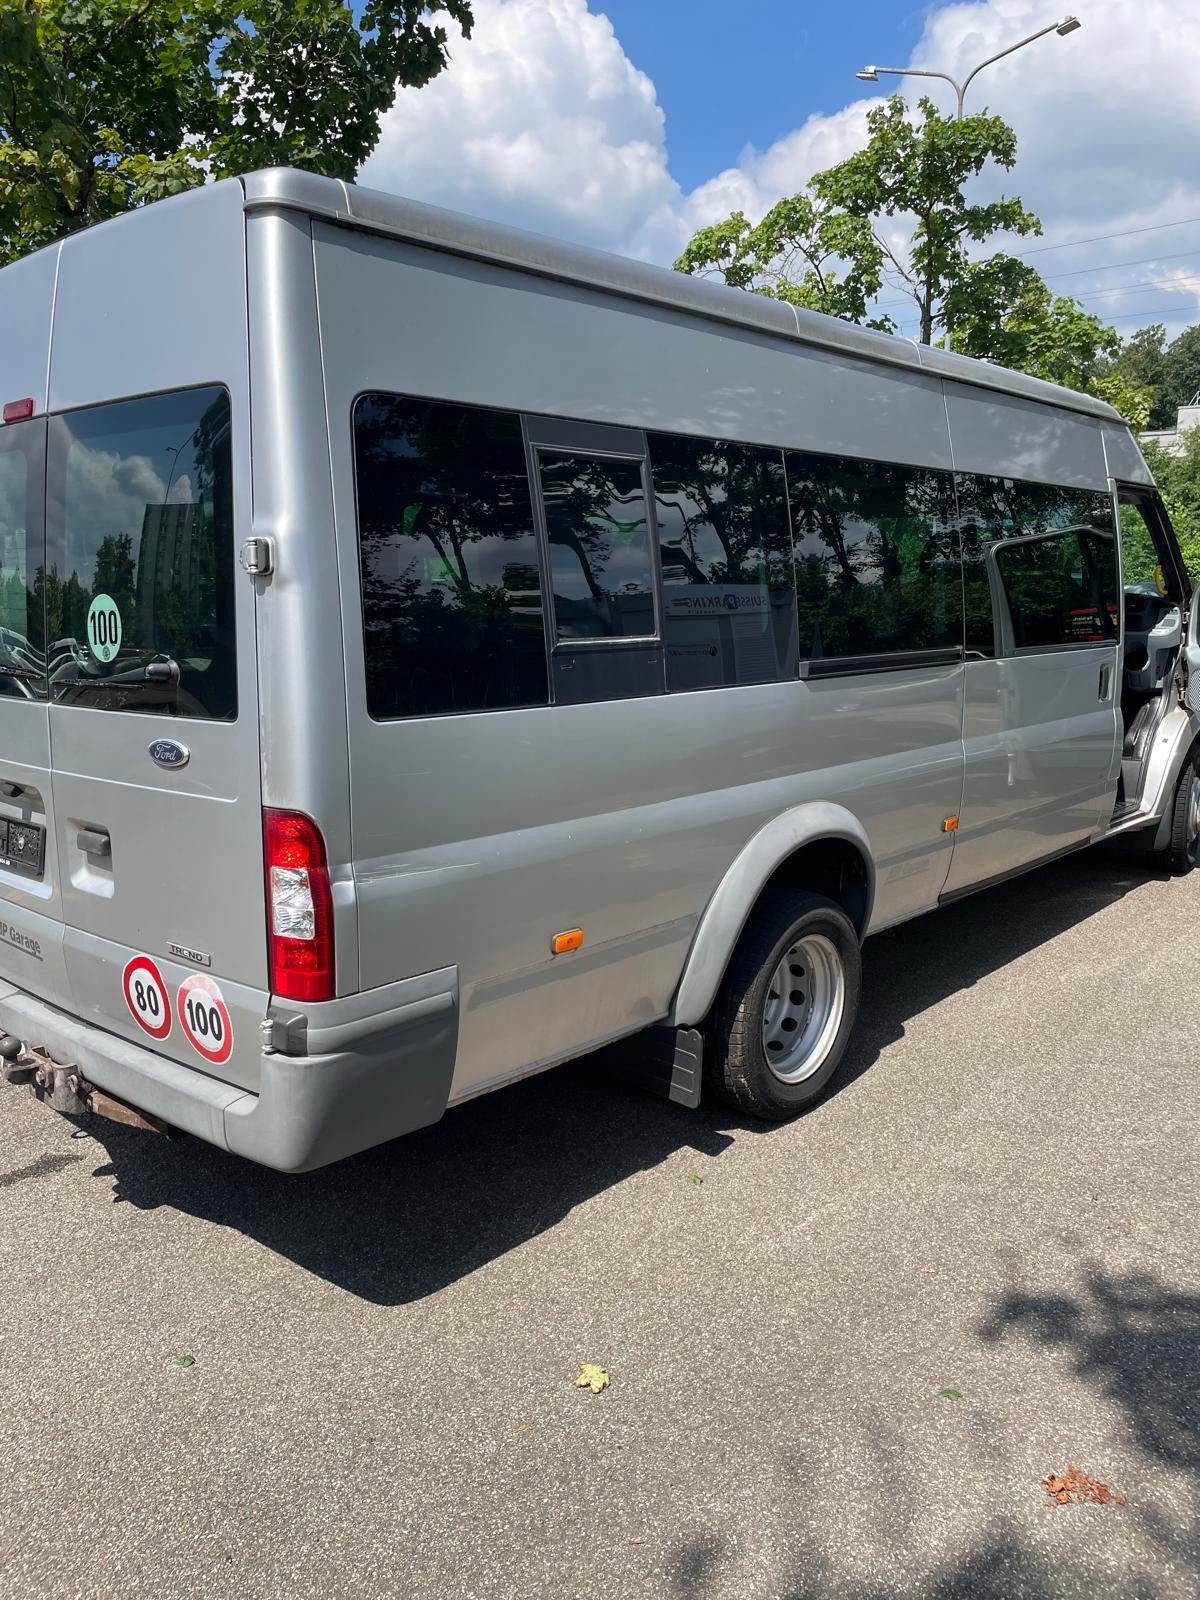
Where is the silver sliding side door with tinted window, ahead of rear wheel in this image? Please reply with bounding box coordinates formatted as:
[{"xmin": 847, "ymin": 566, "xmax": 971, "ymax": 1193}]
[{"xmin": 944, "ymin": 474, "xmax": 1122, "ymax": 894}]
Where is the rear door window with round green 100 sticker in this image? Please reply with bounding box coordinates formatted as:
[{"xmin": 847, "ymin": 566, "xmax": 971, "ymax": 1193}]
[{"xmin": 46, "ymin": 389, "xmax": 237, "ymax": 722}]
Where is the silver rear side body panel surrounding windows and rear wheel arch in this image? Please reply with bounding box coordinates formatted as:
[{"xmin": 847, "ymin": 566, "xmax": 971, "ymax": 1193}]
[{"xmin": 314, "ymin": 222, "xmax": 963, "ymax": 1098}]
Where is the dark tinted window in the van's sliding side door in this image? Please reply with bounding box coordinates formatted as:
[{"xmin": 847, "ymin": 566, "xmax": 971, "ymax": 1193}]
[{"xmin": 958, "ymin": 474, "xmax": 1117, "ymax": 656}]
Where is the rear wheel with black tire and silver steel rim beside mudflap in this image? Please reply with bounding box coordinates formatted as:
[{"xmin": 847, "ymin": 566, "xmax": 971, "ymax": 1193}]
[{"xmin": 704, "ymin": 890, "xmax": 862, "ymax": 1122}]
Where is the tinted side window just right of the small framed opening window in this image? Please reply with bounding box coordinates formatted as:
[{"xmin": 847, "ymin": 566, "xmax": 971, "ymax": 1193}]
[{"xmin": 650, "ymin": 434, "xmax": 797, "ymax": 691}]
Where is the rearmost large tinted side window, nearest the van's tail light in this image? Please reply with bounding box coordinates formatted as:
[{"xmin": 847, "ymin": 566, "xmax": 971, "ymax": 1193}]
[{"xmin": 354, "ymin": 394, "xmax": 549, "ymax": 720}]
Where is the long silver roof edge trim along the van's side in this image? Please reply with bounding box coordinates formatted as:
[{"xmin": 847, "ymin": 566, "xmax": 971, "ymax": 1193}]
[{"xmin": 241, "ymin": 166, "xmax": 1128, "ymax": 427}]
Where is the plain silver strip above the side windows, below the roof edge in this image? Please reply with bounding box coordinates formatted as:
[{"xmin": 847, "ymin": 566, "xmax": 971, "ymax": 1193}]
[{"xmin": 314, "ymin": 222, "xmax": 950, "ymax": 469}]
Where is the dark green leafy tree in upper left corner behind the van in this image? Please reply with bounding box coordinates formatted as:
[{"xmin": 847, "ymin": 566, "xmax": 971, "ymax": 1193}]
[{"xmin": 0, "ymin": 0, "xmax": 472, "ymax": 264}]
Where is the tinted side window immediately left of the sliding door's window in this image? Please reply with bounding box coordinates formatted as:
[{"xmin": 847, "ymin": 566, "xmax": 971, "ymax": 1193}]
[{"xmin": 786, "ymin": 451, "xmax": 962, "ymax": 661}]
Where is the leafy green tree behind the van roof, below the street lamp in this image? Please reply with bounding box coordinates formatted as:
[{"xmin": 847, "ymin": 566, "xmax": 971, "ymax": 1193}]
[{"xmin": 675, "ymin": 94, "xmax": 1042, "ymax": 344}]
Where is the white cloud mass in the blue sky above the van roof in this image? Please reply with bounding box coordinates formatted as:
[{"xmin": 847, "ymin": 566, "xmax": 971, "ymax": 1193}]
[{"xmin": 362, "ymin": 0, "xmax": 1200, "ymax": 333}]
